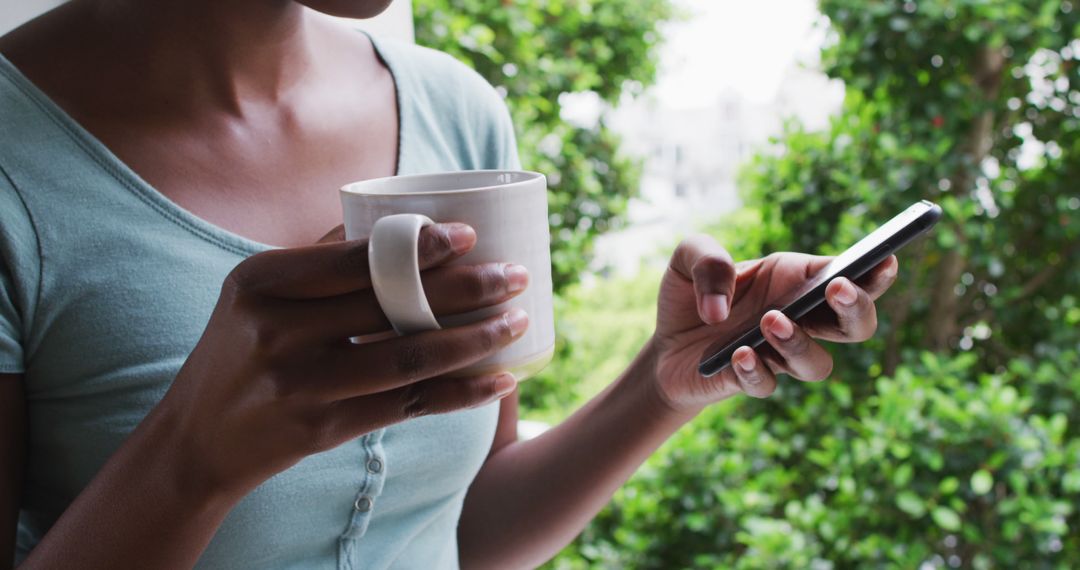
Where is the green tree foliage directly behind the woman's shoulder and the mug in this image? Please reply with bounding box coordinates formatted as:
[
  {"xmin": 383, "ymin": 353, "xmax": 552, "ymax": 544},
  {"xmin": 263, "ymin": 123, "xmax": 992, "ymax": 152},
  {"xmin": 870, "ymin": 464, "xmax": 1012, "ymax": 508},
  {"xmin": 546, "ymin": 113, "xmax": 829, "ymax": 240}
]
[{"xmin": 413, "ymin": 0, "xmax": 672, "ymax": 290}]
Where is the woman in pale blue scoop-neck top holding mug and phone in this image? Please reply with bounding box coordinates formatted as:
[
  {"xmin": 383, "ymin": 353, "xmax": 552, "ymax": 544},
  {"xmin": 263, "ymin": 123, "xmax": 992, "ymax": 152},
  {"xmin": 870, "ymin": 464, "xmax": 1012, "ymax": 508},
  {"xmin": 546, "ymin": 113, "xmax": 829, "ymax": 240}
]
[{"xmin": 0, "ymin": 0, "xmax": 896, "ymax": 568}]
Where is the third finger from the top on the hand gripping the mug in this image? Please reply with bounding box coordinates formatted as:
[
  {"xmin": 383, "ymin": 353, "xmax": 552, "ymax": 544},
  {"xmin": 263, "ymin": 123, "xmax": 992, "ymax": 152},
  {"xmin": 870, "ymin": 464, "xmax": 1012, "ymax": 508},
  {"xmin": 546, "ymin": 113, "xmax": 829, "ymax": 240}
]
[{"xmin": 319, "ymin": 309, "xmax": 528, "ymax": 399}]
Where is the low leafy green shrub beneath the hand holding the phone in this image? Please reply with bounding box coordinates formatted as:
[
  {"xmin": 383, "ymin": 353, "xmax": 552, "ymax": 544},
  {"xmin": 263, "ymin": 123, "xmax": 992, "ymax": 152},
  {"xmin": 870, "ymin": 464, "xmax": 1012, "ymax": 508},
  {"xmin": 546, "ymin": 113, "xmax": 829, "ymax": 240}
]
[{"xmin": 549, "ymin": 345, "xmax": 1080, "ymax": 568}]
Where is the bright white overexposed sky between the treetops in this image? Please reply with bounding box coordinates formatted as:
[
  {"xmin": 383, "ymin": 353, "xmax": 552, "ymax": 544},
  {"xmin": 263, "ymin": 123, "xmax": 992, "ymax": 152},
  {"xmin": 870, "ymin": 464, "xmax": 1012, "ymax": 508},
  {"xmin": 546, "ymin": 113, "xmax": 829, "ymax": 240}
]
[{"xmin": 653, "ymin": 0, "xmax": 824, "ymax": 108}]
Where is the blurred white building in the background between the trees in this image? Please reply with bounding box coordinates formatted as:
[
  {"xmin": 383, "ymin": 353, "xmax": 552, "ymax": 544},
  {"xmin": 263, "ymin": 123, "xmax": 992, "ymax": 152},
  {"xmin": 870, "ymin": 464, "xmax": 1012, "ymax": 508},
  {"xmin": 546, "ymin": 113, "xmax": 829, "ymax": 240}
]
[{"xmin": 594, "ymin": 60, "xmax": 843, "ymax": 274}]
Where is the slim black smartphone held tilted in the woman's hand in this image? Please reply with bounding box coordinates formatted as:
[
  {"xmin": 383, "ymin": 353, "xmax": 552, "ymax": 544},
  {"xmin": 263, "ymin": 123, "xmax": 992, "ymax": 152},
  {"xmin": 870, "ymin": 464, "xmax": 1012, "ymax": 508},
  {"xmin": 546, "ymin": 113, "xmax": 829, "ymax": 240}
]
[{"xmin": 698, "ymin": 200, "xmax": 942, "ymax": 377}]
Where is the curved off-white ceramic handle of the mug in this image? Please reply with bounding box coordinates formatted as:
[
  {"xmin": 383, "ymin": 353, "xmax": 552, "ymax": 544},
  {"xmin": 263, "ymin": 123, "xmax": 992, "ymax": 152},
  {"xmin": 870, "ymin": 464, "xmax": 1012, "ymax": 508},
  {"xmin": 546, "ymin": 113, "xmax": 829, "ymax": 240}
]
[{"xmin": 367, "ymin": 214, "xmax": 442, "ymax": 335}]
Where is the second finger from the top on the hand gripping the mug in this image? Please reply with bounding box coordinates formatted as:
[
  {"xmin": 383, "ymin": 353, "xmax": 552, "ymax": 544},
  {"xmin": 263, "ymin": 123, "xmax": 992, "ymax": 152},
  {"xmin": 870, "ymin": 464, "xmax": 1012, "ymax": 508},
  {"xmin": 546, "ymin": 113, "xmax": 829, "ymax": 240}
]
[{"xmin": 278, "ymin": 263, "xmax": 529, "ymax": 341}]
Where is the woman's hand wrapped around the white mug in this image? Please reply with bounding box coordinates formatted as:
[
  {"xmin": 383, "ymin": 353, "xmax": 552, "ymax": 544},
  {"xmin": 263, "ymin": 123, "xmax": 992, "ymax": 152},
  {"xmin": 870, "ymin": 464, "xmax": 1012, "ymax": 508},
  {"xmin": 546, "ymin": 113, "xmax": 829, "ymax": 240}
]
[{"xmin": 147, "ymin": 223, "xmax": 528, "ymax": 499}]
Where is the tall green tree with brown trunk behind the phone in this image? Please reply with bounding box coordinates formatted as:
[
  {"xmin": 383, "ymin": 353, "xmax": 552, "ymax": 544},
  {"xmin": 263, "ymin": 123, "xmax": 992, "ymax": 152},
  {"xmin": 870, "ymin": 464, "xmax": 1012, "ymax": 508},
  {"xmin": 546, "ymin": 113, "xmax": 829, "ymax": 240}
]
[{"xmin": 744, "ymin": 0, "xmax": 1080, "ymax": 372}]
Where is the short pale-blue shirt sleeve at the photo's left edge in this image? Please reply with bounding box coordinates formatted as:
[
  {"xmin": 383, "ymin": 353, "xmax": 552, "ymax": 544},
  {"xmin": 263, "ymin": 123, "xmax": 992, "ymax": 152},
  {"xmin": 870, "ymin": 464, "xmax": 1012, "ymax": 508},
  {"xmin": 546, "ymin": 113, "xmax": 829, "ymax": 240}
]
[{"xmin": 0, "ymin": 168, "xmax": 40, "ymax": 374}]
